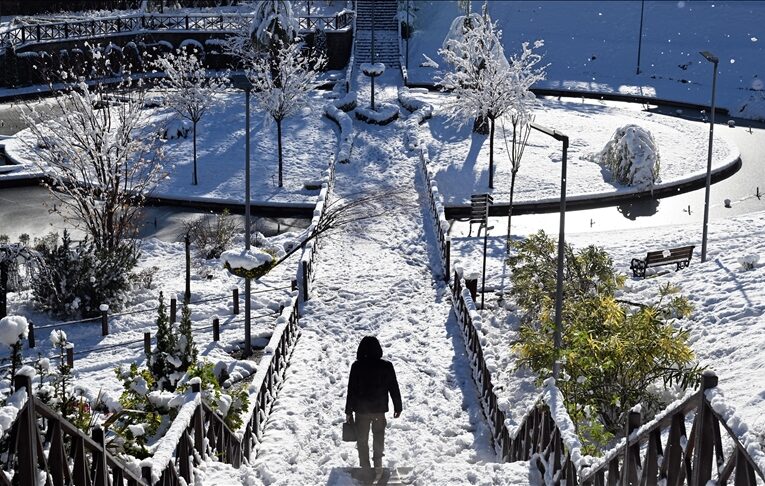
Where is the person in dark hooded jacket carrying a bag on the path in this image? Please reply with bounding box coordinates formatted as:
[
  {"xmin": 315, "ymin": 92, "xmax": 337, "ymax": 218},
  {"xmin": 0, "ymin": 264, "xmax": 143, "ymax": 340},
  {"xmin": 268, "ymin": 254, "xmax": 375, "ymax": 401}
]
[{"xmin": 345, "ymin": 336, "xmax": 402, "ymax": 476}]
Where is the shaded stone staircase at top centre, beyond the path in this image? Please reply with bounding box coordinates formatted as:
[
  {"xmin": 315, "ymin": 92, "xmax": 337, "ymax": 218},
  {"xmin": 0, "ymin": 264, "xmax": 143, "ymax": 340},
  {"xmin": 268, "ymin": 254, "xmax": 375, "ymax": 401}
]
[{"xmin": 354, "ymin": 0, "xmax": 400, "ymax": 69}]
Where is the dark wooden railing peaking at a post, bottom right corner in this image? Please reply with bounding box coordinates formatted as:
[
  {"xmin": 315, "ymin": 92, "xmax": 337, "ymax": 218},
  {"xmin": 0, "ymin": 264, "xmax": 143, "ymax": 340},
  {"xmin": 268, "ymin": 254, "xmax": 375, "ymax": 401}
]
[{"xmin": 579, "ymin": 371, "xmax": 765, "ymax": 486}]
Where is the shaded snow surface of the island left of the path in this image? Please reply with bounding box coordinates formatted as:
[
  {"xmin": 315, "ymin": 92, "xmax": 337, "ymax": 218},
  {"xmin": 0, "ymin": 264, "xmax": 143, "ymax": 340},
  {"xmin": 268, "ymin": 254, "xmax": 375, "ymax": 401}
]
[{"xmin": 0, "ymin": 92, "xmax": 335, "ymax": 205}]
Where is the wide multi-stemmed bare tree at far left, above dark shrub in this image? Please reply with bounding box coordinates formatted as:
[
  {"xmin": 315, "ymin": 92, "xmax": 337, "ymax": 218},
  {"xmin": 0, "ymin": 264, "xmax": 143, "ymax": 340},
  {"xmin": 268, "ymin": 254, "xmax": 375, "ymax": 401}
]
[{"xmin": 22, "ymin": 74, "xmax": 160, "ymax": 254}]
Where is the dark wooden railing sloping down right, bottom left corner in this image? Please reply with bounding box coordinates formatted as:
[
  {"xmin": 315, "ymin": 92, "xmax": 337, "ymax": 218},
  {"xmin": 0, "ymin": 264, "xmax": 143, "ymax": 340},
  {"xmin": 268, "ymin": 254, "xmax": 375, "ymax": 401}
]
[{"xmin": 0, "ymin": 375, "xmax": 146, "ymax": 486}]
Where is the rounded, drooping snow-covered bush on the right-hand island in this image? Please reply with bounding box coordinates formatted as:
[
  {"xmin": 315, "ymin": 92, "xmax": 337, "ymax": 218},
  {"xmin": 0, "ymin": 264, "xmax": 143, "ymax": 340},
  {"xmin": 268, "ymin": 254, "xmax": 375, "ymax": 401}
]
[{"xmin": 590, "ymin": 125, "xmax": 660, "ymax": 189}]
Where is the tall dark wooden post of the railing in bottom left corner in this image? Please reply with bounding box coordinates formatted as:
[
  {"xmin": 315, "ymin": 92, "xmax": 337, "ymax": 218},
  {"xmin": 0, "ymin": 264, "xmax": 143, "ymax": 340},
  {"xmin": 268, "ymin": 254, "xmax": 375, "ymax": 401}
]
[{"xmin": 13, "ymin": 375, "xmax": 39, "ymax": 484}]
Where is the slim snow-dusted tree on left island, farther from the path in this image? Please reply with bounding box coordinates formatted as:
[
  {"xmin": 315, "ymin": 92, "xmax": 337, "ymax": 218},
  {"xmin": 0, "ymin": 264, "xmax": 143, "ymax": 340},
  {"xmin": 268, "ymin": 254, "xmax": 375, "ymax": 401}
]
[{"xmin": 155, "ymin": 48, "xmax": 228, "ymax": 186}]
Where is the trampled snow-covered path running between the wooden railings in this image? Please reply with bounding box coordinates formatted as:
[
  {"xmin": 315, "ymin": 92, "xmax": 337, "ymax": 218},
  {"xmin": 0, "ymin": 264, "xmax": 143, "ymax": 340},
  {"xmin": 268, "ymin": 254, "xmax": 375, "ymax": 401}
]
[{"xmin": 233, "ymin": 75, "xmax": 529, "ymax": 485}]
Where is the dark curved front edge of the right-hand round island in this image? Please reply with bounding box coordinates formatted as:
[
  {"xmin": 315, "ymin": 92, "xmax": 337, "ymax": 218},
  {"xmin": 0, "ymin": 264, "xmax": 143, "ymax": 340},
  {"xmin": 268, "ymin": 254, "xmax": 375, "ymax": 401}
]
[{"xmin": 444, "ymin": 156, "xmax": 741, "ymax": 219}]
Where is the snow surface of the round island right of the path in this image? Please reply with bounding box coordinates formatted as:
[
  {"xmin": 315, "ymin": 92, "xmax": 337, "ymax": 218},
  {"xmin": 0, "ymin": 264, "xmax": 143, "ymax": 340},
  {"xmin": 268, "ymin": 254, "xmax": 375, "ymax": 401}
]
[{"xmin": 414, "ymin": 93, "xmax": 739, "ymax": 205}]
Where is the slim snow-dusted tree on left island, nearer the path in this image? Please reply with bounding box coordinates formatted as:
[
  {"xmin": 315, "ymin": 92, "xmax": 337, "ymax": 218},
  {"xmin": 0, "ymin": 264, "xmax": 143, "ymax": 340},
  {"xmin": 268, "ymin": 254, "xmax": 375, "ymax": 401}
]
[{"xmin": 245, "ymin": 38, "xmax": 324, "ymax": 187}]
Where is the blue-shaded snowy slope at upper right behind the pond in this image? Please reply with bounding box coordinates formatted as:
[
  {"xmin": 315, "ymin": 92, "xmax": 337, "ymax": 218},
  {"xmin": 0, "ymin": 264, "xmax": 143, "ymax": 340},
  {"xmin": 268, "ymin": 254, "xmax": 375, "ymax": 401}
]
[{"xmin": 409, "ymin": 0, "xmax": 765, "ymax": 120}]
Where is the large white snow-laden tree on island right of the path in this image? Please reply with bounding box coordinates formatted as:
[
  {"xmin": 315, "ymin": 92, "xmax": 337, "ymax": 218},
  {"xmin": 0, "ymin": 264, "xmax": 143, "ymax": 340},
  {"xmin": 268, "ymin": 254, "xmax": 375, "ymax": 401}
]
[{"xmin": 438, "ymin": 5, "xmax": 514, "ymax": 188}]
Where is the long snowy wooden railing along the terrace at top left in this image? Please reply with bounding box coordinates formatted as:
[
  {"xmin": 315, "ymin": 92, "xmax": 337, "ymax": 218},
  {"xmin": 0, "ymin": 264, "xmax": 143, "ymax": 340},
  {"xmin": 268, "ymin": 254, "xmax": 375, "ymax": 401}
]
[{"xmin": 0, "ymin": 11, "xmax": 354, "ymax": 49}]
